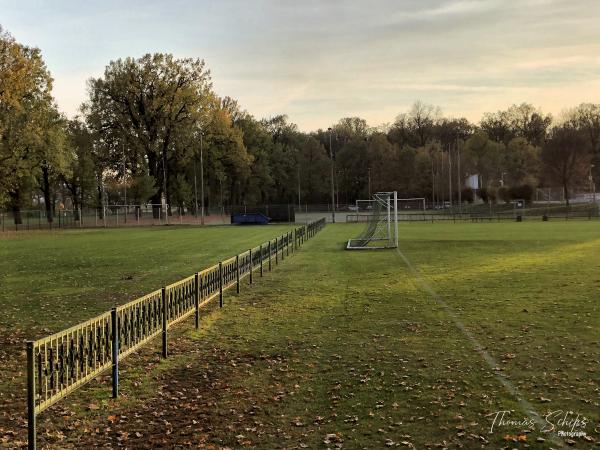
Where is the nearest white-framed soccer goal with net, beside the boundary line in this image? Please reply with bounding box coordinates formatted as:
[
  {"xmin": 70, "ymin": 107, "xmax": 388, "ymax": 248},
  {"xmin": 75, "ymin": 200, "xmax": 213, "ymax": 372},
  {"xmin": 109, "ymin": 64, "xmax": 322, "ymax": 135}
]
[{"xmin": 346, "ymin": 192, "xmax": 398, "ymax": 250}]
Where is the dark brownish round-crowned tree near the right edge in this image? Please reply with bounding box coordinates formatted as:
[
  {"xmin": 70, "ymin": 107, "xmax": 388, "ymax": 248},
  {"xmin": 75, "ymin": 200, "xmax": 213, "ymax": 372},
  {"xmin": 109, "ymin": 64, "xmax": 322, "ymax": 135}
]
[{"xmin": 542, "ymin": 124, "xmax": 591, "ymax": 206}]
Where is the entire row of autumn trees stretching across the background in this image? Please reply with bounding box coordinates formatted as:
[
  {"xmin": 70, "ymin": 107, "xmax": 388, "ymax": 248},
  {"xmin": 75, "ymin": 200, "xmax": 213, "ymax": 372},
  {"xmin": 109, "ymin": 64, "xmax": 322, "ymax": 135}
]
[{"xmin": 0, "ymin": 25, "xmax": 600, "ymax": 220}]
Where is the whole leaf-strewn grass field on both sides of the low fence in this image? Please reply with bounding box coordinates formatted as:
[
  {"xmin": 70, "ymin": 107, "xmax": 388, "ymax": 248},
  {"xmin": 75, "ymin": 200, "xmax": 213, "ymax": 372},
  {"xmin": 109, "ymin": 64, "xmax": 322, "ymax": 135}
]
[{"xmin": 0, "ymin": 222, "xmax": 600, "ymax": 449}]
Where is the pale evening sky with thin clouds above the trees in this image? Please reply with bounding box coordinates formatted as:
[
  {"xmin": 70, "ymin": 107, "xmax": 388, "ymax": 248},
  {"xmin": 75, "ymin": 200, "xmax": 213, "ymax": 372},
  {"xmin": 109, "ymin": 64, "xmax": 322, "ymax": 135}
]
[{"xmin": 0, "ymin": 0, "xmax": 600, "ymax": 131}]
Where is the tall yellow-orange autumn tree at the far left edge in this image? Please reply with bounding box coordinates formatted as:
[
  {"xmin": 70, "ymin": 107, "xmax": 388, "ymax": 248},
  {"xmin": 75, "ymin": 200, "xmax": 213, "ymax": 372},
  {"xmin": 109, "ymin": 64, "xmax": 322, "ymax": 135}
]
[{"xmin": 0, "ymin": 28, "xmax": 68, "ymax": 223}]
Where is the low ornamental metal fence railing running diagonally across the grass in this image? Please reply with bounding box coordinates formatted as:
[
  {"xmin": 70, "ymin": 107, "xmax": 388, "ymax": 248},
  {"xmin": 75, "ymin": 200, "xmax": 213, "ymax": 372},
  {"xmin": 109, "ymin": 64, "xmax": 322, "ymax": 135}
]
[{"xmin": 27, "ymin": 219, "xmax": 325, "ymax": 449}]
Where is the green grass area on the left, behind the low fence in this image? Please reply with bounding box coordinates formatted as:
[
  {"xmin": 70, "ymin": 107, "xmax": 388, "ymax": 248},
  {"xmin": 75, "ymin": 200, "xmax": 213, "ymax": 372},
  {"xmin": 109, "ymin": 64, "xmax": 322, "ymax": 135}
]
[{"xmin": 0, "ymin": 225, "xmax": 290, "ymax": 339}]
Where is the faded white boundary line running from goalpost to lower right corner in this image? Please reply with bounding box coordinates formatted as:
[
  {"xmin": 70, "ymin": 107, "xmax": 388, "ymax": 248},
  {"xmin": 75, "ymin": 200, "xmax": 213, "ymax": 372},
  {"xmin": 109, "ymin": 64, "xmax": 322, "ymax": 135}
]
[{"xmin": 396, "ymin": 248, "xmax": 565, "ymax": 447}]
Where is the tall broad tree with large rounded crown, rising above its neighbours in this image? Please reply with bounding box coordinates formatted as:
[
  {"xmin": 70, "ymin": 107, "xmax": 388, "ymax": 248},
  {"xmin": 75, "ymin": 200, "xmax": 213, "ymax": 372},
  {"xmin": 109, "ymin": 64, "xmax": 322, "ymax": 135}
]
[{"xmin": 85, "ymin": 53, "xmax": 215, "ymax": 214}]
